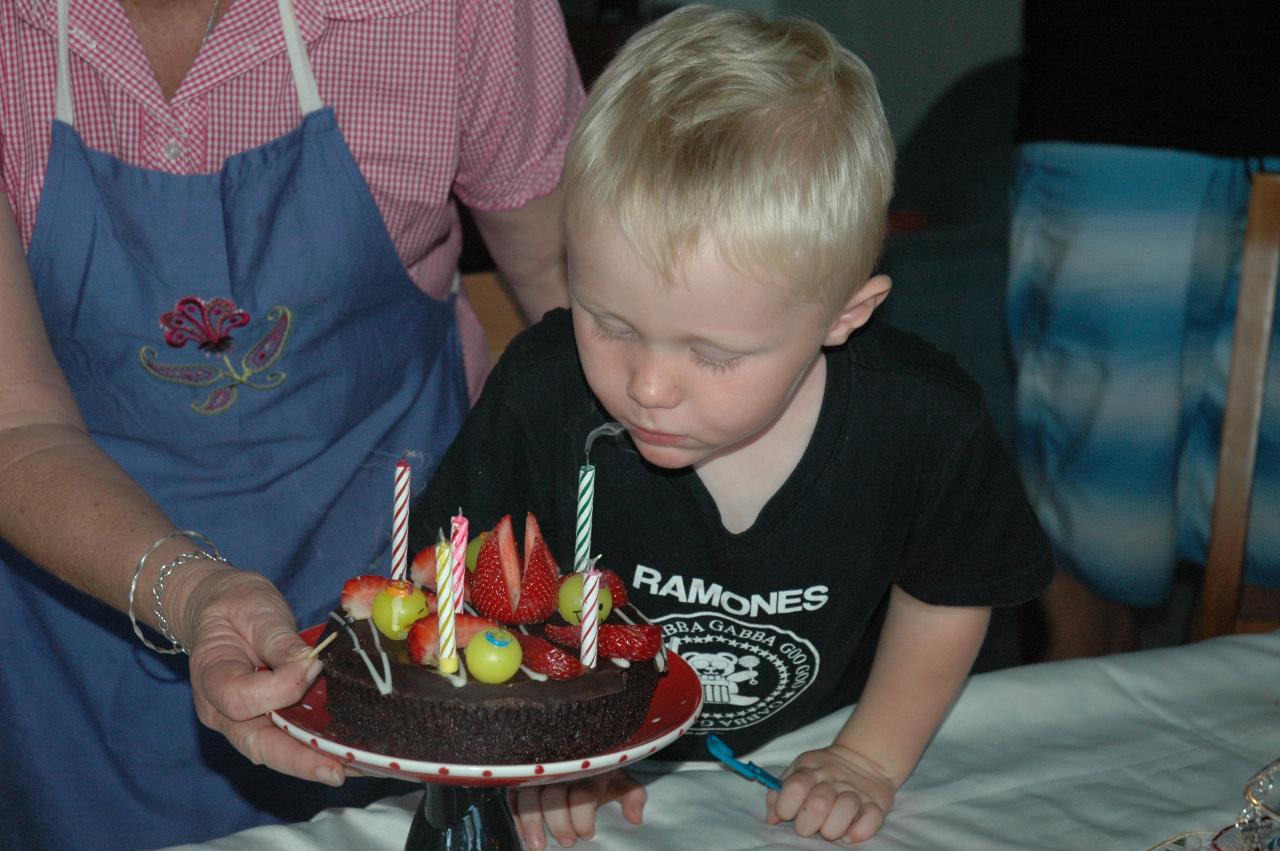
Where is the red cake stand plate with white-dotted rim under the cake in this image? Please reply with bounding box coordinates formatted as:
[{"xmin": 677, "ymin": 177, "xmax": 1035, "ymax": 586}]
[{"xmin": 266, "ymin": 624, "xmax": 703, "ymax": 786}]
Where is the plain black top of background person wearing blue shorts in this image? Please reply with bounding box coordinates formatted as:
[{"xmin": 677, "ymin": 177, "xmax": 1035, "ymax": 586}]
[{"xmin": 1019, "ymin": 0, "xmax": 1280, "ymax": 156}]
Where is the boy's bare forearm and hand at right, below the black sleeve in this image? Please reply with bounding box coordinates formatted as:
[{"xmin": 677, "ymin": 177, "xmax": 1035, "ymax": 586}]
[{"xmin": 767, "ymin": 585, "xmax": 991, "ymax": 842}]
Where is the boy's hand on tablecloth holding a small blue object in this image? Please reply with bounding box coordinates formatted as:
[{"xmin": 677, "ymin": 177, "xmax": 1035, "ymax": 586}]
[{"xmin": 765, "ymin": 745, "xmax": 895, "ymax": 842}]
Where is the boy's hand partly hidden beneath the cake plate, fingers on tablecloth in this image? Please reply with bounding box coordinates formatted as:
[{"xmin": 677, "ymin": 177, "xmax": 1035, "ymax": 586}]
[{"xmin": 511, "ymin": 770, "xmax": 646, "ymax": 851}]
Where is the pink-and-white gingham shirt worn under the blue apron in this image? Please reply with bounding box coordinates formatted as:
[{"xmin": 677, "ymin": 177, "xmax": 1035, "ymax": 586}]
[{"xmin": 0, "ymin": 0, "xmax": 582, "ymax": 394}]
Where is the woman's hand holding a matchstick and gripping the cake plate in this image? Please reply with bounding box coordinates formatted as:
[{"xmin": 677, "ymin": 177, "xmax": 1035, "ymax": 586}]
[{"xmin": 170, "ymin": 564, "xmax": 344, "ymax": 786}]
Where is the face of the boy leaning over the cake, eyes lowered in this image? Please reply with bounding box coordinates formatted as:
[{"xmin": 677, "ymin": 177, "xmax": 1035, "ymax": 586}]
[{"xmin": 567, "ymin": 217, "xmax": 887, "ymax": 468}]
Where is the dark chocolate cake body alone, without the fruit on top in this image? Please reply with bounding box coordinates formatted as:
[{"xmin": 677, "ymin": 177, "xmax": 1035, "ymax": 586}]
[{"xmin": 321, "ymin": 605, "xmax": 666, "ymax": 765}]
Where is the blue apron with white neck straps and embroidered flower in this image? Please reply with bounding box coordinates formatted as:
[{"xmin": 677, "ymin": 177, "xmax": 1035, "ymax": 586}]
[{"xmin": 0, "ymin": 0, "xmax": 467, "ymax": 848}]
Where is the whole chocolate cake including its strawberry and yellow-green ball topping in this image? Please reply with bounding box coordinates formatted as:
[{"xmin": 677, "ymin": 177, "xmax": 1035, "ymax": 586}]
[{"xmin": 321, "ymin": 514, "xmax": 666, "ymax": 765}]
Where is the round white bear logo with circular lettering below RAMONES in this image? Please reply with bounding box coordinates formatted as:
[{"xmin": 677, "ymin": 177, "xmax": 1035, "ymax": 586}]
[{"xmin": 654, "ymin": 612, "xmax": 818, "ymax": 733}]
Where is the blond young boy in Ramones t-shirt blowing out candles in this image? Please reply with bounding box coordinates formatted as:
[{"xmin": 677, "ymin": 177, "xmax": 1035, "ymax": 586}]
[{"xmin": 412, "ymin": 6, "xmax": 1051, "ymax": 847}]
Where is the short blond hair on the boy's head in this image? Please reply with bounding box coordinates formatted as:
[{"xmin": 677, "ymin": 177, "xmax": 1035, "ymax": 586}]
[{"xmin": 563, "ymin": 6, "xmax": 893, "ymax": 303}]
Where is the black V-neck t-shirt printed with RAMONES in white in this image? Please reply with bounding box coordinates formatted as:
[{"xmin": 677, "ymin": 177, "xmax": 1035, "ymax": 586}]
[{"xmin": 411, "ymin": 311, "xmax": 1052, "ymax": 758}]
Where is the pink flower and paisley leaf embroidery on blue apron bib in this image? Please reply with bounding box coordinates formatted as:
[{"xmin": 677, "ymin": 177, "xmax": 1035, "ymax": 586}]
[{"xmin": 138, "ymin": 296, "xmax": 293, "ymax": 413}]
